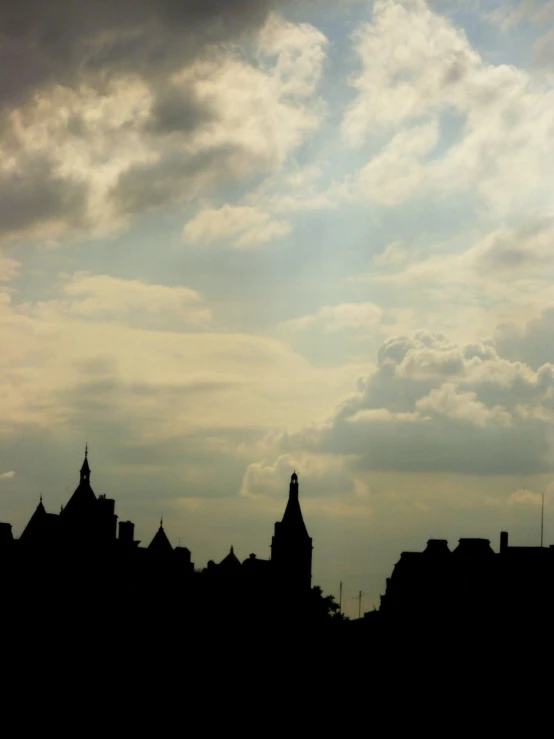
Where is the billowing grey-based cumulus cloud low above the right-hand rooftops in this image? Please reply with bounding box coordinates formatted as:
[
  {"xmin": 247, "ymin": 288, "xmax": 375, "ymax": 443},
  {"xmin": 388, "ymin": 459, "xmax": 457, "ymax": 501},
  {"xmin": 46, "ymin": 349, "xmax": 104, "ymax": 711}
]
[{"xmin": 282, "ymin": 331, "xmax": 554, "ymax": 474}]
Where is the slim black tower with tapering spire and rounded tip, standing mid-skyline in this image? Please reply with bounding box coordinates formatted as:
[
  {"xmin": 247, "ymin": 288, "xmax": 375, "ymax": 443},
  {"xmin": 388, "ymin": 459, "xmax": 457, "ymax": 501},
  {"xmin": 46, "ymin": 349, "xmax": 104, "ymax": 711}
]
[{"xmin": 271, "ymin": 472, "xmax": 313, "ymax": 591}]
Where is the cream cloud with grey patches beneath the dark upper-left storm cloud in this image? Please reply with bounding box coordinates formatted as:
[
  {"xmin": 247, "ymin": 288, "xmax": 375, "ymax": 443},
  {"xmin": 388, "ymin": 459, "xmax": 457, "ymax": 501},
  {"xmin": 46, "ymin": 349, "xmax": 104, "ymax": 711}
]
[{"xmin": 0, "ymin": 15, "xmax": 326, "ymax": 239}]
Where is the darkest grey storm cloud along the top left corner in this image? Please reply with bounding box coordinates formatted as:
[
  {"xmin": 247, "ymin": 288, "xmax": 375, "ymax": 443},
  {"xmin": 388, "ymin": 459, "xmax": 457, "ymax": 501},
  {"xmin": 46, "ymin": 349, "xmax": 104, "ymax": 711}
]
[{"xmin": 0, "ymin": 0, "xmax": 284, "ymax": 103}]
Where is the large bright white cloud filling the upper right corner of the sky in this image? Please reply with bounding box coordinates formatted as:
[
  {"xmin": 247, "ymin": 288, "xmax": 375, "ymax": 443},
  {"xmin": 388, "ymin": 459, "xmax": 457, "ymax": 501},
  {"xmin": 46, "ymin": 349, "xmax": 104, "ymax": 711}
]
[{"xmin": 343, "ymin": 0, "xmax": 554, "ymax": 213}]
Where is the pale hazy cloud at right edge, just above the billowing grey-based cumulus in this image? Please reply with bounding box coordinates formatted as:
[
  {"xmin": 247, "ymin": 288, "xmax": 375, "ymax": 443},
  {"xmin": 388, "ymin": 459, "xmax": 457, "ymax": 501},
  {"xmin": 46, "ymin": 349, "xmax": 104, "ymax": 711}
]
[{"xmin": 353, "ymin": 215, "xmax": 554, "ymax": 346}]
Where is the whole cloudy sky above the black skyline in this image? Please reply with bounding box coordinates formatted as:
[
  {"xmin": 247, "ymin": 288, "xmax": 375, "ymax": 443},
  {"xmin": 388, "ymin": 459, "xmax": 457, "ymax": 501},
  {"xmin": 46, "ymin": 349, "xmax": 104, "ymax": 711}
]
[{"xmin": 0, "ymin": 0, "xmax": 554, "ymax": 616}]
